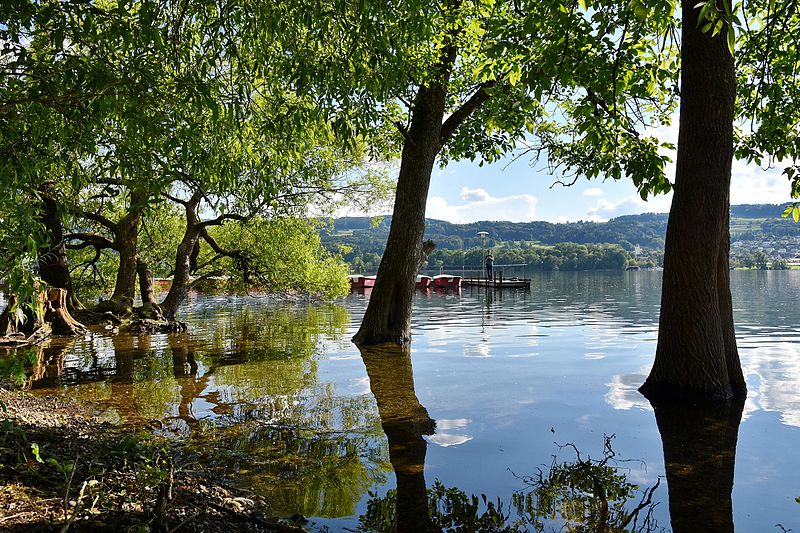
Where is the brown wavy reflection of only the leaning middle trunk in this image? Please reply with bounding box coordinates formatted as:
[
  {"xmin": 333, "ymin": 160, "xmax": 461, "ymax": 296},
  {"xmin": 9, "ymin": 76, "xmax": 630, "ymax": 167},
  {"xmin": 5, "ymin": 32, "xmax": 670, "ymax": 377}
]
[{"xmin": 361, "ymin": 345, "xmax": 436, "ymax": 531}]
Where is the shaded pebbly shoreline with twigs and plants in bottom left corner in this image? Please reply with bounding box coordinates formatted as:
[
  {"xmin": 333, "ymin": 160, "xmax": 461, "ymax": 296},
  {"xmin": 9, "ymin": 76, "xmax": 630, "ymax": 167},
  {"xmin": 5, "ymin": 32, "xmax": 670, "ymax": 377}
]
[{"xmin": 0, "ymin": 386, "xmax": 306, "ymax": 532}]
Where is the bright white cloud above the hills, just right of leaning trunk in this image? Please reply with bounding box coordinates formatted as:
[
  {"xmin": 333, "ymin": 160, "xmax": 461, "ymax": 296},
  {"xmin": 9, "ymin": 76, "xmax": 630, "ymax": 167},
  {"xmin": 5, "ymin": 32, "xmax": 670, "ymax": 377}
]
[{"xmin": 426, "ymin": 187, "xmax": 539, "ymax": 224}]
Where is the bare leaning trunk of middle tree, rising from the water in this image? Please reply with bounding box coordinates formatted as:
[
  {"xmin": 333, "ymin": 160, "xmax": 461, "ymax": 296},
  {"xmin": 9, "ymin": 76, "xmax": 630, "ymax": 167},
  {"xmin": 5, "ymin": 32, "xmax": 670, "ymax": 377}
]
[{"xmin": 353, "ymin": 80, "xmax": 447, "ymax": 345}]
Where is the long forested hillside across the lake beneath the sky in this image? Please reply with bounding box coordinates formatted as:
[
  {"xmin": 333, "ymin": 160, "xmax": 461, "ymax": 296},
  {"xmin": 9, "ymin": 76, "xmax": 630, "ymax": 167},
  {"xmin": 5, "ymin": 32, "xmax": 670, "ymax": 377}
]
[{"xmin": 321, "ymin": 204, "xmax": 800, "ymax": 270}]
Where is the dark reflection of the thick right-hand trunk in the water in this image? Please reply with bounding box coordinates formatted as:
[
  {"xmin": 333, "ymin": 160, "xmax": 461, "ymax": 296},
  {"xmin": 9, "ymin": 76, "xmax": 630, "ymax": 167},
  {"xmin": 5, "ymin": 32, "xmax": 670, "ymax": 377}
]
[{"xmin": 654, "ymin": 400, "xmax": 744, "ymax": 533}]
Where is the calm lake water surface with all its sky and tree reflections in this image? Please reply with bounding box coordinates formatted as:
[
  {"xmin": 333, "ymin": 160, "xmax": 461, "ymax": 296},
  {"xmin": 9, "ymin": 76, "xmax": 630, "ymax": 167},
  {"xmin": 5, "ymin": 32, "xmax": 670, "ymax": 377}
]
[{"xmin": 23, "ymin": 271, "xmax": 800, "ymax": 532}]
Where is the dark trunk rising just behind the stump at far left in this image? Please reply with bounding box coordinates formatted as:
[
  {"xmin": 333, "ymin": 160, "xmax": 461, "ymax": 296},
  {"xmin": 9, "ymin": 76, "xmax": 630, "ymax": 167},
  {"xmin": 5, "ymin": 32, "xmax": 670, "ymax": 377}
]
[{"xmin": 38, "ymin": 183, "xmax": 84, "ymax": 311}]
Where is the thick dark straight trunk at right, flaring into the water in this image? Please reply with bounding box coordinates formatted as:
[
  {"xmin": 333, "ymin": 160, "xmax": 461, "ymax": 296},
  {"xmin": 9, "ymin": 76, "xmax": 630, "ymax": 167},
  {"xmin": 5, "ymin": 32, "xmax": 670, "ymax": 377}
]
[{"xmin": 640, "ymin": 0, "xmax": 745, "ymax": 401}]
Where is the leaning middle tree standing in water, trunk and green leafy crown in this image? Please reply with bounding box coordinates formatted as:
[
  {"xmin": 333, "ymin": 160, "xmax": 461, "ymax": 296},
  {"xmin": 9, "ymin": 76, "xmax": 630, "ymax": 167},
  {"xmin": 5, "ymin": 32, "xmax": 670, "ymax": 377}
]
[{"xmin": 346, "ymin": 0, "xmax": 672, "ymax": 345}]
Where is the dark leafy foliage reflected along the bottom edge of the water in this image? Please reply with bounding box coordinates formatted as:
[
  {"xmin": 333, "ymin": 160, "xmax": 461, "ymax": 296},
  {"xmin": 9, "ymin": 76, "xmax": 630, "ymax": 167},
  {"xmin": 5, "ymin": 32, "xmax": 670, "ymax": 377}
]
[{"xmin": 359, "ymin": 435, "xmax": 660, "ymax": 533}]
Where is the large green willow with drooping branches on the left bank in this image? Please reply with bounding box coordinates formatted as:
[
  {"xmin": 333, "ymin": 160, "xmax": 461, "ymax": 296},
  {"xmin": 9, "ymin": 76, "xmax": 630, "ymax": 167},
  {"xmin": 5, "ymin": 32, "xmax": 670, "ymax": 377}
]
[{"xmin": 0, "ymin": 0, "xmax": 388, "ymax": 320}]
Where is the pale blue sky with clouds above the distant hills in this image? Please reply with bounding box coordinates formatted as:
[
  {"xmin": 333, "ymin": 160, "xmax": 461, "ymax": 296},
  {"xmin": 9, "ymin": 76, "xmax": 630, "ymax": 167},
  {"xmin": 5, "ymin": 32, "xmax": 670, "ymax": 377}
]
[{"xmin": 426, "ymin": 124, "xmax": 791, "ymax": 223}]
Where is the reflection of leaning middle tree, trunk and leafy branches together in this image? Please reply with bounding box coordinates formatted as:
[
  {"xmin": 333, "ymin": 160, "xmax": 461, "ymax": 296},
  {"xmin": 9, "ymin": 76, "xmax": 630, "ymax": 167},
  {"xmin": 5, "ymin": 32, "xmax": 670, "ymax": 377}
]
[{"xmin": 359, "ymin": 345, "xmax": 659, "ymax": 532}]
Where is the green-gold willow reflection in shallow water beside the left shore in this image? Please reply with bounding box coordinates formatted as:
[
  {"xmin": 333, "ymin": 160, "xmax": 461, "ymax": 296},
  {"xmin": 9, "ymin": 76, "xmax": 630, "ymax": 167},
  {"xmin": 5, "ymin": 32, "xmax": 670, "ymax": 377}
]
[{"xmin": 24, "ymin": 302, "xmax": 391, "ymax": 517}]
